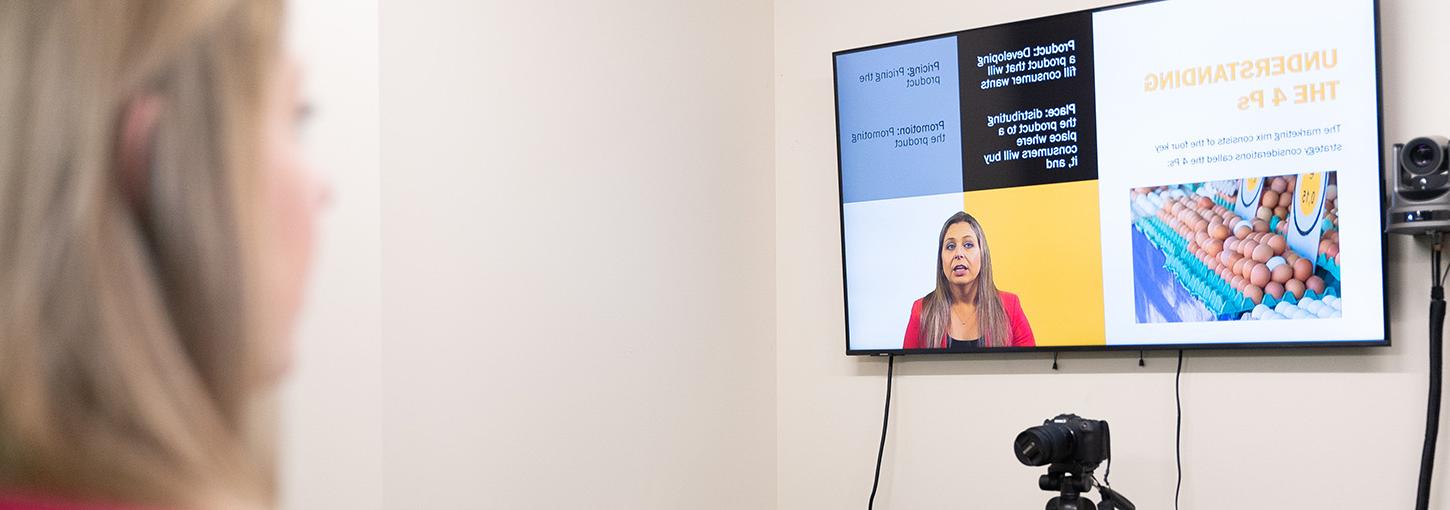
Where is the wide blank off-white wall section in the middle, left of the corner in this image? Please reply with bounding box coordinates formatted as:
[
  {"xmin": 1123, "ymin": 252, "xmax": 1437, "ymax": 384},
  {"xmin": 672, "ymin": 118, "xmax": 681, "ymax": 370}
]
[{"xmin": 380, "ymin": 0, "xmax": 776, "ymax": 509}]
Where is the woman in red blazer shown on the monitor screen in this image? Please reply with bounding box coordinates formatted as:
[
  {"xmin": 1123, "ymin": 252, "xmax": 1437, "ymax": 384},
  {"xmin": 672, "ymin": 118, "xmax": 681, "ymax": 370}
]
[{"xmin": 902, "ymin": 212, "xmax": 1037, "ymax": 349}]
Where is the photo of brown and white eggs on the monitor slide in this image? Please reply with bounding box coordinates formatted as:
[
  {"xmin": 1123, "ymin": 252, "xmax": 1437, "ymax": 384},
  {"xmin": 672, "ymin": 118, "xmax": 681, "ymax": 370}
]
[{"xmin": 1130, "ymin": 172, "xmax": 1343, "ymax": 323}]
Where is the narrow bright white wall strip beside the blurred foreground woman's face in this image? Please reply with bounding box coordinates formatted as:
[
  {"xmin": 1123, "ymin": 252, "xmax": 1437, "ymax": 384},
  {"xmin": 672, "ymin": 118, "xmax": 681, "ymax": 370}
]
[{"xmin": 278, "ymin": 0, "xmax": 384, "ymax": 510}]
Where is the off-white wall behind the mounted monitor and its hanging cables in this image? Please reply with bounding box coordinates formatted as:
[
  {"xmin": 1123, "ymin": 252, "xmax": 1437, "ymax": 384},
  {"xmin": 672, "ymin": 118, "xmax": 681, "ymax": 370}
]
[{"xmin": 774, "ymin": 0, "xmax": 1450, "ymax": 509}]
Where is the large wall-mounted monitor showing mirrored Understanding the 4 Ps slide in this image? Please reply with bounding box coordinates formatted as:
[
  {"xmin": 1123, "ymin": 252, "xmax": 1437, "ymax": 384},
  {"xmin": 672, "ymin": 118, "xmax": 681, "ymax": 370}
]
[{"xmin": 832, "ymin": 0, "xmax": 1389, "ymax": 355}]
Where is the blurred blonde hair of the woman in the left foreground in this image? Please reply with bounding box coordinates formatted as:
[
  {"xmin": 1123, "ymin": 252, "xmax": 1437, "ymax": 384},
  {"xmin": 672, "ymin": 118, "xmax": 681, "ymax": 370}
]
[{"xmin": 0, "ymin": 0, "xmax": 283, "ymax": 507}]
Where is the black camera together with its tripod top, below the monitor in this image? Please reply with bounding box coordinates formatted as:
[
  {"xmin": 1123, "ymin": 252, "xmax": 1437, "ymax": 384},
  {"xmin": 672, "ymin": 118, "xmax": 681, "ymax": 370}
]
[{"xmin": 1012, "ymin": 414, "xmax": 1135, "ymax": 510}]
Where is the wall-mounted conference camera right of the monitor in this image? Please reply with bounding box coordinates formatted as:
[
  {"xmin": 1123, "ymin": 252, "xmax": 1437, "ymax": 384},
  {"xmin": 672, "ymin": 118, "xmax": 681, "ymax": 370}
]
[{"xmin": 1385, "ymin": 136, "xmax": 1450, "ymax": 235}]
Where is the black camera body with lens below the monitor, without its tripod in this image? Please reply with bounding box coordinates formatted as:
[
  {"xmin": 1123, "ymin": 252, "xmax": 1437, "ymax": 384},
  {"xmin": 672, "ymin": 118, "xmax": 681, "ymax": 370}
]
[{"xmin": 1012, "ymin": 414, "xmax": 1112, "ymax": 469}]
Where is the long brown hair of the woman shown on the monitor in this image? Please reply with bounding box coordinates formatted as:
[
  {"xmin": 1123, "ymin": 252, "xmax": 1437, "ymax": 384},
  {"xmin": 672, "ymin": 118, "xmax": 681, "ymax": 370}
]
[{"xmin": 919, "ymin": 212, "xmax": 1012, "ymax": 348}]
